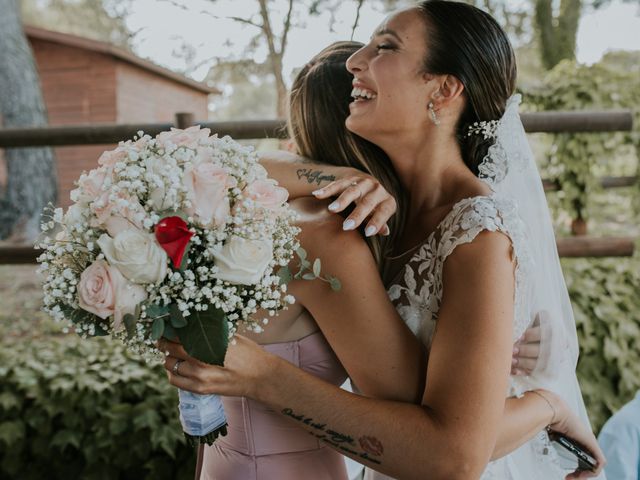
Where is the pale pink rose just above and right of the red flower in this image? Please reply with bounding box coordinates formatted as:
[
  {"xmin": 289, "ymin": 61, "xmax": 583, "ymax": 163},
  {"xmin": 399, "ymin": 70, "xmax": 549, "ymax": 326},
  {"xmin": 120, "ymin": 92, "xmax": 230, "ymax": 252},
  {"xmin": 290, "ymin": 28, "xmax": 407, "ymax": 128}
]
[{"xmin": 182, "ymin": 162, "xmax": 237, "ymax": 228}]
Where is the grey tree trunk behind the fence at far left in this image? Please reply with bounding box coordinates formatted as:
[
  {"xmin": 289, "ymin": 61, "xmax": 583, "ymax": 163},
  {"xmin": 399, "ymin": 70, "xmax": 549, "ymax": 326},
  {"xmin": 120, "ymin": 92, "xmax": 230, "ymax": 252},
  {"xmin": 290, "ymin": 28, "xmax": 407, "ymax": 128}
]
[{"xmin": 0, "ymin": 0, "xmax": 57, "ymax": 241}]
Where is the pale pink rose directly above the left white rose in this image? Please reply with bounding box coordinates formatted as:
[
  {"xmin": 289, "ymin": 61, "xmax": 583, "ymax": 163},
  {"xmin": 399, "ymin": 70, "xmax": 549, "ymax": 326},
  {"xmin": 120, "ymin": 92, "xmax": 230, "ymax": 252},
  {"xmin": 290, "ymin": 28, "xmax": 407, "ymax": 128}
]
[{"xmin": 90, "ymin": 192, "xmax": 144, "ymax": 237}]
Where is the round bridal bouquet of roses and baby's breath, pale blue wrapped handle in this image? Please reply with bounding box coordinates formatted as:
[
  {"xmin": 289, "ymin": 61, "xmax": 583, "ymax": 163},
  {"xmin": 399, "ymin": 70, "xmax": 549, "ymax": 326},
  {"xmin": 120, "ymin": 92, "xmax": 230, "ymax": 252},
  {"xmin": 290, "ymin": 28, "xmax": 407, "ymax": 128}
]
[{"xmin": 38, "ymin": 126, "xmax": 308, "ymax": 443}]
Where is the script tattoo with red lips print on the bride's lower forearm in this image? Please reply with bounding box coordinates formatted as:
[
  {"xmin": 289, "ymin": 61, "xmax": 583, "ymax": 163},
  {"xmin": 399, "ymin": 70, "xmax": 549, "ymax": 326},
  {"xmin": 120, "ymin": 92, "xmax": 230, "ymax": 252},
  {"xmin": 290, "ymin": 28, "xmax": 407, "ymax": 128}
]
[{"xmin": 282, "ymin": 408, "xmax": 384, "ymax": 465}]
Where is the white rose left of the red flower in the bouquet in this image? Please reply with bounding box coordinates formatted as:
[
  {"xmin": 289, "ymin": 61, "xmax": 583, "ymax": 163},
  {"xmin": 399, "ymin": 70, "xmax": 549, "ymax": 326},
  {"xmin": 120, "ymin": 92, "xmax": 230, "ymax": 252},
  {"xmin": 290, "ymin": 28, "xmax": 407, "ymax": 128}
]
[{"xmin": 97, "ymin": 228, "xmax": 167, "ymax": 283}]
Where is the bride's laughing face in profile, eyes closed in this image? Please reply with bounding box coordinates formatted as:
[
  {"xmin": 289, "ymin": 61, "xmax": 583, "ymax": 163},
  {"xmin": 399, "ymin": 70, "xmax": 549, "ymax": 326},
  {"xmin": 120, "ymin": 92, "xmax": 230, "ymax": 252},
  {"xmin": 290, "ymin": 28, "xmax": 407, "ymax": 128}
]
[{"xmin": 346, "ymin": 8, "xmax": 437, "ymax": 143}]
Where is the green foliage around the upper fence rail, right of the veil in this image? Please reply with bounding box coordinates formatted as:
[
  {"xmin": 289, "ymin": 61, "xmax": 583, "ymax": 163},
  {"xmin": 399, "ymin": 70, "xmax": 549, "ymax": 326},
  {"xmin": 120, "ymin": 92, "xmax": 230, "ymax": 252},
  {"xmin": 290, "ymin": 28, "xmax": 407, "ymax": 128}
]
[{"xmin": 526, "ymin": 58, "xmax": 640, "ymax": 223}]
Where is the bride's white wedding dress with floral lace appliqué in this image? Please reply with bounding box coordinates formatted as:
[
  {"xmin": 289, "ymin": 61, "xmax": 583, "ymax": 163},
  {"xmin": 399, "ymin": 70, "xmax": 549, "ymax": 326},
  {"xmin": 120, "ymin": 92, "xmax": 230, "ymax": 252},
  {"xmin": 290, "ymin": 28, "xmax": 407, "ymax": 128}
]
[{"xmin": 365, "ymin": 194, "xmax": 567, "ymax": 480}]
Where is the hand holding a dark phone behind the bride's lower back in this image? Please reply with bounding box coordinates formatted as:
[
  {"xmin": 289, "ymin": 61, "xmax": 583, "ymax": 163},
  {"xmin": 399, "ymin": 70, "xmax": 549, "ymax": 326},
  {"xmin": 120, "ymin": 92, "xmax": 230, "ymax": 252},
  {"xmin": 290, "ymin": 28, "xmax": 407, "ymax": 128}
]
[{"xmin": 537, "ymin": 390, "xmax": 607, "ymax": 479}]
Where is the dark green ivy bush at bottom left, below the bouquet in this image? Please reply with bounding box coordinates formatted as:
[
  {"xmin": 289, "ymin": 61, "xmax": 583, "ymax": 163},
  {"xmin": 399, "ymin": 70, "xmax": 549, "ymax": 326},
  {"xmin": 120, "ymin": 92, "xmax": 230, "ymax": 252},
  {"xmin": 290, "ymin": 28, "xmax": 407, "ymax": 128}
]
[{"xmin": 0, "ymin": 335, "xmax": 195, "ymax": 480}]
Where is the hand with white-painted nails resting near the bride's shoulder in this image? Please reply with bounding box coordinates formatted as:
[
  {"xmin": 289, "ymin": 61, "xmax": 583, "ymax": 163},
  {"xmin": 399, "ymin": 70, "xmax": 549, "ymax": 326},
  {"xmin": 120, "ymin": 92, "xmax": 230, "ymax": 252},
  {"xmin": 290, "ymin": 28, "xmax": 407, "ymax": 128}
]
[{"xmin": 313, "ymin": 169, "xmax": 398, "ymax": 237}]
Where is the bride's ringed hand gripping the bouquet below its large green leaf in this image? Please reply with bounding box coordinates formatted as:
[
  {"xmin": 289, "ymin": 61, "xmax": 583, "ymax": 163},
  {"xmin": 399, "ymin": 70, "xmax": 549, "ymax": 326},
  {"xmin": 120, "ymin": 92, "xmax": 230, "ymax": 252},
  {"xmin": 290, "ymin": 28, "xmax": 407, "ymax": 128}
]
[{"xmin": 158, "ymin": 335, "xmax": 279, "ymax": 399}]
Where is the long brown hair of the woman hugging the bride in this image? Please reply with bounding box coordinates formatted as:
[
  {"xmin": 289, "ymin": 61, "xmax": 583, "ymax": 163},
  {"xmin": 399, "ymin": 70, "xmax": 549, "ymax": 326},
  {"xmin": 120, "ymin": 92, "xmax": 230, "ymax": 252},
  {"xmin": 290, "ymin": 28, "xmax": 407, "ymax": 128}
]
[{"xmin": 287, "ymin": 42, "xmax": 405, "ymax": 272}]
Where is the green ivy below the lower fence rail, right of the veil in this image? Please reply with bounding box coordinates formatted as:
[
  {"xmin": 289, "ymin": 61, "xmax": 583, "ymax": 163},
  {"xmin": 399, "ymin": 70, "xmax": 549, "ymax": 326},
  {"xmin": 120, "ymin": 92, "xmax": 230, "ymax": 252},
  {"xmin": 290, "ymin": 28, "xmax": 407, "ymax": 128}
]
[{"xmin": 562, "ymin": 254, "xmax": 640, "ymax": 430}]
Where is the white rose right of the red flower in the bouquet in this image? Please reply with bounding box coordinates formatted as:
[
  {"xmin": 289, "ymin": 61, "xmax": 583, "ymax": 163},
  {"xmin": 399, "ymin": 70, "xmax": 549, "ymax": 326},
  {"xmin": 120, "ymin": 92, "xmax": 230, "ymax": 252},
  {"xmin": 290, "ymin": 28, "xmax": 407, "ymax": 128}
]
[{"xmin": 213, "ymin": 236, "xmax": 273, "ymax": 285}]
